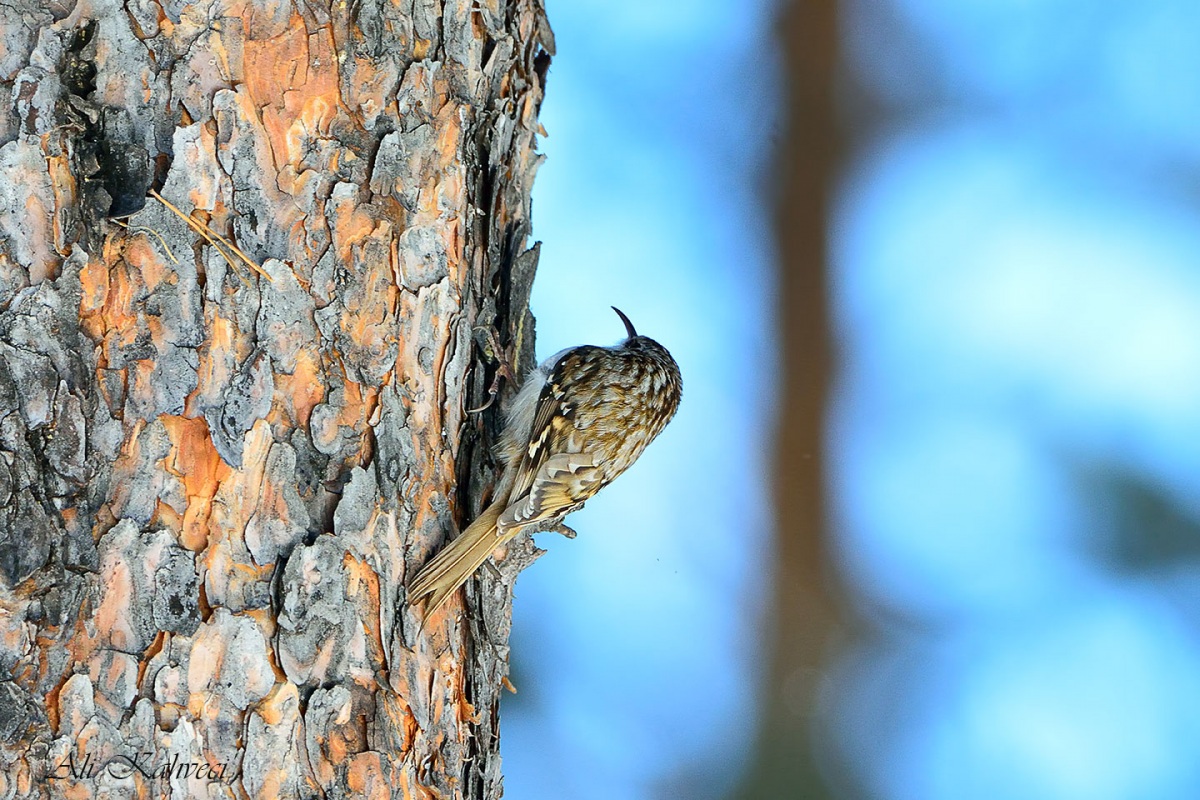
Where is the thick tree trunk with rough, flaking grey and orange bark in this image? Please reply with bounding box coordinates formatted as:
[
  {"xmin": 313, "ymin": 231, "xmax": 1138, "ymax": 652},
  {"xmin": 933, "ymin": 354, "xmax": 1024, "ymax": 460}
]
[{"xmin": 0, "ymin": 0, "xmax": 553, "ymax": 798}]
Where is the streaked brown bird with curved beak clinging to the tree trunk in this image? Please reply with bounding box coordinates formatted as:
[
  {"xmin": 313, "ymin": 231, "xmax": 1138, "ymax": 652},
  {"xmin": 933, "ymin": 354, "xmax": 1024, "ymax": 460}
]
[{"xmin": 408, "ymin": 307, "xmax": 683, "ymax": 619}]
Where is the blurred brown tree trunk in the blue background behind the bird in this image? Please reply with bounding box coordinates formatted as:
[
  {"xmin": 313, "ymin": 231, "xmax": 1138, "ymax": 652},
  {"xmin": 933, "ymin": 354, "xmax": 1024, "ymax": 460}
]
[{"xmin": 736, "ymin": 0, "xmax": 840, "ymax": 800}]
